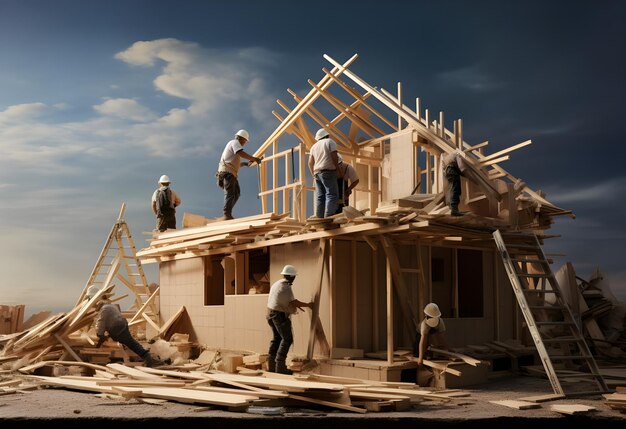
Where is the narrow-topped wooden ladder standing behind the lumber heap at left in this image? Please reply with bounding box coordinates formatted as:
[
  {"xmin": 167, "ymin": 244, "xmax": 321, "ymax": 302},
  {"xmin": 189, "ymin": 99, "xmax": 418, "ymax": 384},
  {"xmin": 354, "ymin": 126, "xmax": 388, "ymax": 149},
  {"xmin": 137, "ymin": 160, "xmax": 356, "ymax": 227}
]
[{"xmin": 77, "ymin": 203, "xmax": 159, "ymax": 330}]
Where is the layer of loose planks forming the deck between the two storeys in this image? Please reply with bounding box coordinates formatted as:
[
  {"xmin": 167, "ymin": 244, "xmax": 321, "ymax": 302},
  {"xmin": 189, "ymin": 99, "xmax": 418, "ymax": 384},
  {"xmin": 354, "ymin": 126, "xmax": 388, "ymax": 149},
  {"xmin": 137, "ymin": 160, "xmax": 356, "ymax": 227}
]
[{"xmin": 137, "ymin": 201, "xmax": 564, "ymax": 262}]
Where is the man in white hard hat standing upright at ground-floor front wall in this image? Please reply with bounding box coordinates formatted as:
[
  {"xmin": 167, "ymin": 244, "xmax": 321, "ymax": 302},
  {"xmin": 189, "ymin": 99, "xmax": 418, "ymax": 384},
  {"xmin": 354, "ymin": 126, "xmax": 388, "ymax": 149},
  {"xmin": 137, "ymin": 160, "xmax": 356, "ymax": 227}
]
[{"xmin": 267, "ymin": 265, "xmax": 313, "ymax": 374}]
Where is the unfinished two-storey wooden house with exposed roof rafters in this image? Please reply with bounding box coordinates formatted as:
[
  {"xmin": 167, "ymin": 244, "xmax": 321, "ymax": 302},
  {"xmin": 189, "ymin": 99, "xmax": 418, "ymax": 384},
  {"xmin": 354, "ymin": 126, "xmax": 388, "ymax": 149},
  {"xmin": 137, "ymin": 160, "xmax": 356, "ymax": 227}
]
[{"xmin": 137, "ymin": 55, "xmax": 604, "ymax": 390}]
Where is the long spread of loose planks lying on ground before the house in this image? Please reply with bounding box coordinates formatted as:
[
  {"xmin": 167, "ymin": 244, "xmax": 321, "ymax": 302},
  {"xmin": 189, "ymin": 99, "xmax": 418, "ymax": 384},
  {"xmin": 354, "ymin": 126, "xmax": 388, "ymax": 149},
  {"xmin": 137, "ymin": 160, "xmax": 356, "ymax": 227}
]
[{"xmin": 11, "ymin": 362, "xmax": 469, "ymax": 413}]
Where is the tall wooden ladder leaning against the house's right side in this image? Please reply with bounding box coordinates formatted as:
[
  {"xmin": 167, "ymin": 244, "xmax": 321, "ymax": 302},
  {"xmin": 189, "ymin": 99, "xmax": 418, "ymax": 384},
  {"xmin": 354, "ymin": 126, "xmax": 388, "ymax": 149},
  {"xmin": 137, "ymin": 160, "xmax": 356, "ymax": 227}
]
[{"xmin": 493, "ymin": 230, "xmax": 609, "ymax": 396}]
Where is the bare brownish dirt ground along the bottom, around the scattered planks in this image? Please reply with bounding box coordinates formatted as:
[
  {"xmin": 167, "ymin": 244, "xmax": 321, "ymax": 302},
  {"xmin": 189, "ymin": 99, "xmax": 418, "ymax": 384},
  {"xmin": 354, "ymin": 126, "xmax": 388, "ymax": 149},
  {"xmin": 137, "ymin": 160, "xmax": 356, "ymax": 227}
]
[{"xmin": 0, "ymin": 376, "xmax": 626, "ymax": 429}]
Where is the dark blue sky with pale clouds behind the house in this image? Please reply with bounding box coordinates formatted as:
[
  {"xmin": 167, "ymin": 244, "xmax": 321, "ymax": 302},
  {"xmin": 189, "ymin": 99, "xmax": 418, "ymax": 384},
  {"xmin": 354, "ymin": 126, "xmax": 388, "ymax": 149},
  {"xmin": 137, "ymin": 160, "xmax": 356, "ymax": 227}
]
[{"xmin": 0, "ymin": 0, "xmax": 626, "ymax": 313}]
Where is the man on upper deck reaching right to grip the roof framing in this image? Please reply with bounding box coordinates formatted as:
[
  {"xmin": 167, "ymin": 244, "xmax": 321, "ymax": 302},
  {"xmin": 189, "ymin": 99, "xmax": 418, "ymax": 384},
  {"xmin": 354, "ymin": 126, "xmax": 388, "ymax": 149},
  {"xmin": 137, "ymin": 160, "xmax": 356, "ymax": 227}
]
[{"xmin": 215, "ymin": 130, "xmax": 261, "ymax": 220}]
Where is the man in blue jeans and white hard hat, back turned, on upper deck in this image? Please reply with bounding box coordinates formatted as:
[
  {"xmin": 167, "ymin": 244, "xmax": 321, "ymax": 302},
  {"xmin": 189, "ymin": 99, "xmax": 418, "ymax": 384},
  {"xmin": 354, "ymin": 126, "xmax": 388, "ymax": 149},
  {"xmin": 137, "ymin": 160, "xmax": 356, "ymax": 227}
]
[{"xmin": 309, "ymin": 128, "xmax": 339, "ymax": 218}]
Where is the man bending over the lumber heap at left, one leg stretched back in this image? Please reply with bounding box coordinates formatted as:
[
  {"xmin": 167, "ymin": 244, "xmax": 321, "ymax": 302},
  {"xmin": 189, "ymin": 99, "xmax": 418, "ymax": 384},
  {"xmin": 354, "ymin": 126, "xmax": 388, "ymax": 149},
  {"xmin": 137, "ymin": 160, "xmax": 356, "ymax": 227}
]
[{"xmin": 87, "ymin": 286, "xmax": 165, "ymax": 367}]
